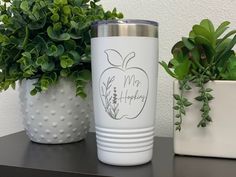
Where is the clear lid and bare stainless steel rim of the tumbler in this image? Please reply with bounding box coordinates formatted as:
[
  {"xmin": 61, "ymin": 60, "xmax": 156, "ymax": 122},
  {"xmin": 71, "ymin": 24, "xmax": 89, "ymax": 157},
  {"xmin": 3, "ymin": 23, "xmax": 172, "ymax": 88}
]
[{"xmin": 91, "ymin": 19, "xmax": 158, "ymax": 38}]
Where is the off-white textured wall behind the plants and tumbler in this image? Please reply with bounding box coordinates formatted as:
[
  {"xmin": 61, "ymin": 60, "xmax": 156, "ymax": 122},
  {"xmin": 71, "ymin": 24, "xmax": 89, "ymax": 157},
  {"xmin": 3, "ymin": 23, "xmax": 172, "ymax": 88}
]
[{"xmin": 0, "ymin": 0, "xmax": 236, "ymax": 136}]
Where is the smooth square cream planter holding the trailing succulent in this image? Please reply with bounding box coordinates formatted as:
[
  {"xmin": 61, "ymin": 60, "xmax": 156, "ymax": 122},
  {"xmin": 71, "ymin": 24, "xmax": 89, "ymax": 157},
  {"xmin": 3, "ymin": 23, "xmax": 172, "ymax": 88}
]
[{"xmin": 174, "ymin": 81, "xmax": 236, "ymax": 158}]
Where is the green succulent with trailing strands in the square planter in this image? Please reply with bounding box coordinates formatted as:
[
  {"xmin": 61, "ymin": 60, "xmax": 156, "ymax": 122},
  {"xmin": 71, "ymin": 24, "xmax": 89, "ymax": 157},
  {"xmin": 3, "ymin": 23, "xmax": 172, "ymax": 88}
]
[{"xmin": 160, "ymin": 19, "xmax": 236, "ymax": 131}]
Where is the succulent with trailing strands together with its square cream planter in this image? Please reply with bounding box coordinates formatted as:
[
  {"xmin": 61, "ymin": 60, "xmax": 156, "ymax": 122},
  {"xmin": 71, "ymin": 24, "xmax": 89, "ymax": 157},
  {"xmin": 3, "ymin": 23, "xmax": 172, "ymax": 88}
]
[{"xmin": 161, "ymin": 19, "xmax": 236, "ymax": 158}]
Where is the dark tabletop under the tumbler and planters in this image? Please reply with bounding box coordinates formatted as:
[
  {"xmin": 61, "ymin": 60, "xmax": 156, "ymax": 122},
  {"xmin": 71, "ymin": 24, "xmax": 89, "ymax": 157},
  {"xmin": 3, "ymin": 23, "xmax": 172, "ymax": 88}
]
[{"xmin": 0, "ymin": 132, "xmax": 236, "ymax": 177}]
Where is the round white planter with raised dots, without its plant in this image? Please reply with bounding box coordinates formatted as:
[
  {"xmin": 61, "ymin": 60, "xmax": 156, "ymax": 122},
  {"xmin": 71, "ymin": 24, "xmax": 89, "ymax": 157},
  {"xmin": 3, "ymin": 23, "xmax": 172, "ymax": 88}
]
[{"xmin": 20, "ymin": 79, "xmax": 92, "ymax": 144}]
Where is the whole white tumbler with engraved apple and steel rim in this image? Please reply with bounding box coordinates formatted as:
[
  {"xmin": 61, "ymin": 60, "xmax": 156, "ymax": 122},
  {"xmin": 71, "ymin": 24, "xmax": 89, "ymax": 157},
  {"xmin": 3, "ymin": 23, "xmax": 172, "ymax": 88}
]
[{"xmin": 91, "ymin": 20, "xmax": 158, "ymax": 166}]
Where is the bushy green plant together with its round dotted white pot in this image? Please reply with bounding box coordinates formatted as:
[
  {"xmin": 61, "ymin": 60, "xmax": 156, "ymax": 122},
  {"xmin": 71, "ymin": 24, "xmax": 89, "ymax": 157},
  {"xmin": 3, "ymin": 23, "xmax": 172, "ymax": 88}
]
[{"xmin": 0, "ymin": 0, "xmax": 123, "ymax": 144}]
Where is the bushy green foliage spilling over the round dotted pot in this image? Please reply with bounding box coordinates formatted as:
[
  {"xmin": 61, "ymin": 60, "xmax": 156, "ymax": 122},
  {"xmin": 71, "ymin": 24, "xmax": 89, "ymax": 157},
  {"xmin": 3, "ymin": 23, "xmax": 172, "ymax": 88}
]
[{"xmin": 0, "ymin": 0, "xmax": 123, "ymax": 98}]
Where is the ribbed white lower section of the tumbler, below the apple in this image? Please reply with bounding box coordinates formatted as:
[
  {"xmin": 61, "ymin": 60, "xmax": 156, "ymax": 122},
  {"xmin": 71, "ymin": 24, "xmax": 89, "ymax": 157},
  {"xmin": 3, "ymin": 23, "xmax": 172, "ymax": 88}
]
[{"xmin": 96, "ymin": 127, "xmax": 154, "ymax": 166}]
